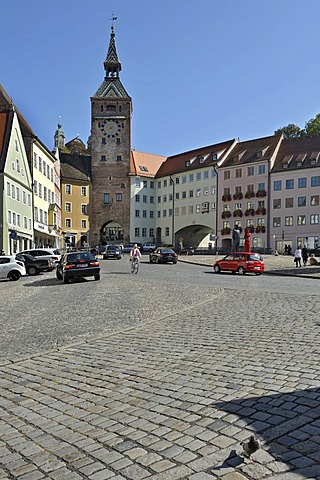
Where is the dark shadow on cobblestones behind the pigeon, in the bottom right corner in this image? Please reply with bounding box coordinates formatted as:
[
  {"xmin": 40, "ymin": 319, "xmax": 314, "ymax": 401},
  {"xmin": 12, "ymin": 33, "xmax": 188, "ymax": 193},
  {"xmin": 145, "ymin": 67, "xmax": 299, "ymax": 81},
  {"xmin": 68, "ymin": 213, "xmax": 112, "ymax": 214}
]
[{"xmin": 214, "ymin": 388, "xmax": 320, "ymax": 479}]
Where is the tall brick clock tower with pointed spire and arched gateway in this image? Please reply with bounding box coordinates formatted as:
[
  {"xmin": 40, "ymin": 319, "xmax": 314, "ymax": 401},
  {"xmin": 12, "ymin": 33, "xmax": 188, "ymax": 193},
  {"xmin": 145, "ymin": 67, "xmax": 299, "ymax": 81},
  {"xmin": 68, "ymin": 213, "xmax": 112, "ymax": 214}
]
[{"xmin": 90, "ymin": 25, "xmax": 132, "ymax": 244}]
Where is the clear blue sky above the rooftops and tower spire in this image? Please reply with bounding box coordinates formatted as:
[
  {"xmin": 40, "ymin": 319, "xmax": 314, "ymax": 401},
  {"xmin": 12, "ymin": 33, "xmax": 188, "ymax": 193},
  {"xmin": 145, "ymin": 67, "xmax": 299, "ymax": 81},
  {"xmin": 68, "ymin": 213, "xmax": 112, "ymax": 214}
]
[{"xmin": 0, "ymin": 0, "xmax": 320, "ymax": 156}]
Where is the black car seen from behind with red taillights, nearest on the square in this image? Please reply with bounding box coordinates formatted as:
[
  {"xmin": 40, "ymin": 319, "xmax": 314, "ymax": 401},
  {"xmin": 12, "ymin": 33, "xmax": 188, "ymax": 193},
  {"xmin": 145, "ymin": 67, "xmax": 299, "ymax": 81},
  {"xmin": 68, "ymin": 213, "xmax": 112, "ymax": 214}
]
[{"xmin": 56, "ymin": 252, "xmax": 100, "ymax": 283}]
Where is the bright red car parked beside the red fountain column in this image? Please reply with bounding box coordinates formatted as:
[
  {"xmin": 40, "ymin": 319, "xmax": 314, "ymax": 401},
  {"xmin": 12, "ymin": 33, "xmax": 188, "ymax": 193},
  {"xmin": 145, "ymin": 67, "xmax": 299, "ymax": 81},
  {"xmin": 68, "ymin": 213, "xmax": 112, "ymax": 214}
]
[{"xmin": 213, "ymin": 252, "xmax": 264, "ymax": 275}]
